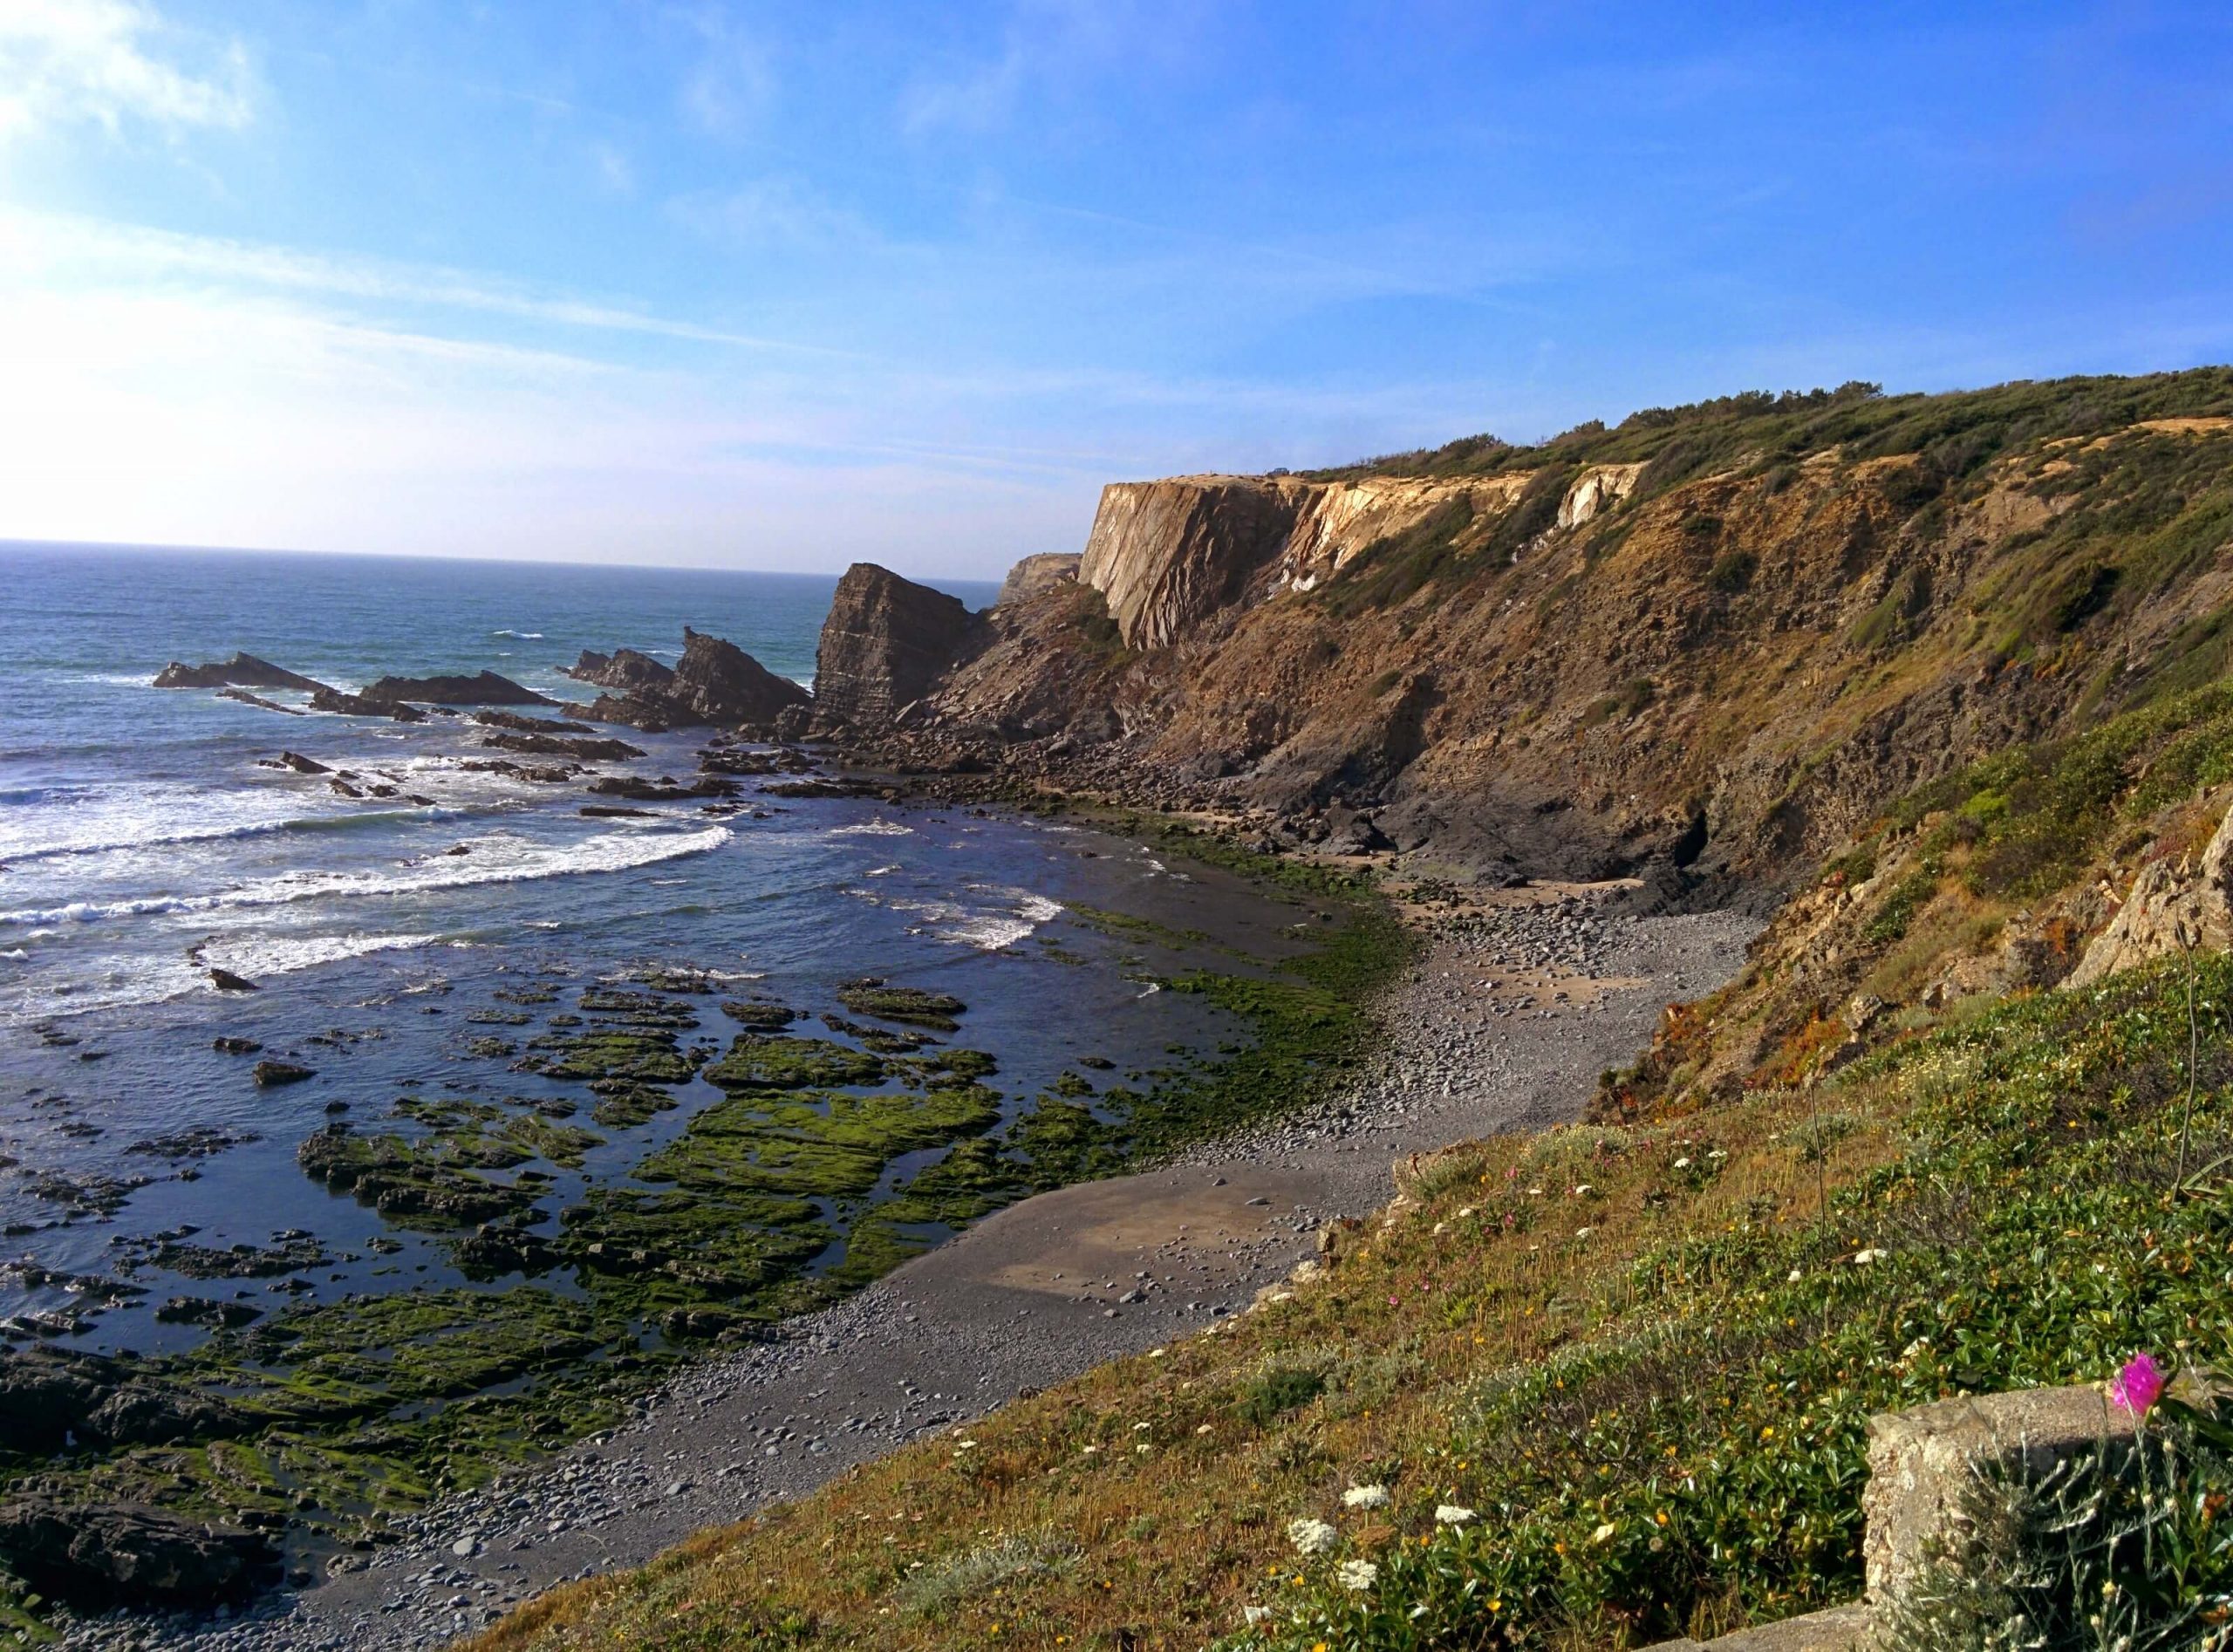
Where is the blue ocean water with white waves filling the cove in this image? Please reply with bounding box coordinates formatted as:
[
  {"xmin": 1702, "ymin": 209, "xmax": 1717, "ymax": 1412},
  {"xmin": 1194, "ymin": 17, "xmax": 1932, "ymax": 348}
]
[{"xmin": 0, "ymin": 545, "xmax": 1295, "ymax": 1350}]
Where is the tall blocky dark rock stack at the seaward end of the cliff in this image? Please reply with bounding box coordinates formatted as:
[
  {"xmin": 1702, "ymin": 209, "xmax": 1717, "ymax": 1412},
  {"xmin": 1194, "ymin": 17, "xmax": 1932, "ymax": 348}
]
[{"xmin": 815, "ymin": 563, "xmax": 978, "ymax": 727}]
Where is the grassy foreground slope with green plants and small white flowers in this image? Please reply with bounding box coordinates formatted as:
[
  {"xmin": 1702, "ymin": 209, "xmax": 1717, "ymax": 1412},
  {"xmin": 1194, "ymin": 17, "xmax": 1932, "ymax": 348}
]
[{"xmin": 471, "ymin": 960, "xmax": 2233, "ymax": 1652}]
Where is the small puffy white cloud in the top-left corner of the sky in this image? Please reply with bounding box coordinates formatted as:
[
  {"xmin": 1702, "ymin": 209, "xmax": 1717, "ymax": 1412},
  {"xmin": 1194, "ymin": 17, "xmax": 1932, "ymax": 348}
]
[{"xmin": 0, "ymin": 0, "xmax": 252, "ymax": 140}]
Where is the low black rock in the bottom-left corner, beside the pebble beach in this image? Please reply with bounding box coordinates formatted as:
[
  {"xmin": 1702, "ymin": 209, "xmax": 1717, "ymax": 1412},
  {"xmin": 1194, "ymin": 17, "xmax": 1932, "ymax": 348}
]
[{"xmin": 0, "ymin": 1496, "xmax": 279, "ymax": 1608}]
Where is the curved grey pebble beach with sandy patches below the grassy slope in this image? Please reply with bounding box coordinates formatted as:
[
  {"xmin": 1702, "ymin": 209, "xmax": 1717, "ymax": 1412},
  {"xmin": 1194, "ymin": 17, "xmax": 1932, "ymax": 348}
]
[{"xmin": 65, "ymin": 886, "xmax": 1755, "ymax": 1652}]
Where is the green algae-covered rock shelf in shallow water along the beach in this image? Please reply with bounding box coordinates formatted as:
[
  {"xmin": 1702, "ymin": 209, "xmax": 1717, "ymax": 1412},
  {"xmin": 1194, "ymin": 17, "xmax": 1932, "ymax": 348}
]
[{"xmin": 0, "ymin": 822, "xmax": 1400, "ymax": 1605}]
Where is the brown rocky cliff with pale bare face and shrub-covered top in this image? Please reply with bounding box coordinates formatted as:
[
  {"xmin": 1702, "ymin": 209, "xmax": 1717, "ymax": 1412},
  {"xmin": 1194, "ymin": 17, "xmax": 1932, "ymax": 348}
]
[{"xmin": 824, "ymin": 368, "xmax": 2233, "ymax": 895}]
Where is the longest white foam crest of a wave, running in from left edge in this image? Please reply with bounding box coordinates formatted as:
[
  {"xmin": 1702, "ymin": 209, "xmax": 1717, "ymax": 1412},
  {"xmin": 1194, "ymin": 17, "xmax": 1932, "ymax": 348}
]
[{"xmin": 0, "ymin": 826, "xmax": 730, "ymax": 929}]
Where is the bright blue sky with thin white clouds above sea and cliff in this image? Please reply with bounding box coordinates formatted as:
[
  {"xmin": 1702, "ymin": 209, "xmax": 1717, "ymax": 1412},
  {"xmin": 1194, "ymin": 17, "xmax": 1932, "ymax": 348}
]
[{"xmin": 0, "ymin": 0, "xmax": 2233, "ymax": 576}]
